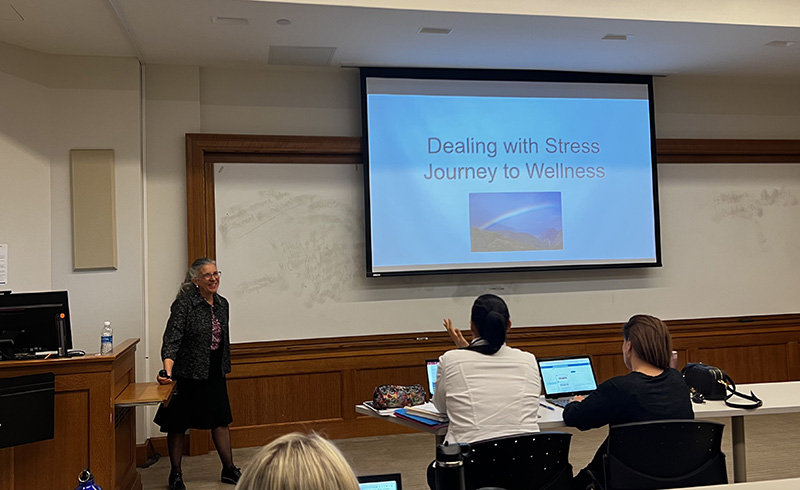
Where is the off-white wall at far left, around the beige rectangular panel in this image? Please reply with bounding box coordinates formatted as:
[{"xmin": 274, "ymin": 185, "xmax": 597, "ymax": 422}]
[{"xmin": 0, "ymin": 40, "xmax": 146, "ymax": 440}]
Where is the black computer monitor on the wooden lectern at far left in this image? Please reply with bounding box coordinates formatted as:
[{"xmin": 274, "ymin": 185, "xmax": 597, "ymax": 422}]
[{"xmin": 0, "ymin": 291, "xmax": 72, "ymax": 355}]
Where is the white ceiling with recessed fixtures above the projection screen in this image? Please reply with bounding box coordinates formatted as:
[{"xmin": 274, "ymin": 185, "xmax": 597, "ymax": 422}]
[{"xmin": 0, "ymin": 0, "xmax": 800, "ymax": 81}]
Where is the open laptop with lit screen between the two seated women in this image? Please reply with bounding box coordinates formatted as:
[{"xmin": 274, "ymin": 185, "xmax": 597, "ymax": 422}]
[{"xmin": 537, "ymin": 356, "xmax": 597, "ymax": 408}]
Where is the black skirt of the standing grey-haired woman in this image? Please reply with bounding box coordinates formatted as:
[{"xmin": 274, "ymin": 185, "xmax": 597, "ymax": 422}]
[{"xmin": 154, "ymin": 349, "xmax": 233, "ymax": 433}]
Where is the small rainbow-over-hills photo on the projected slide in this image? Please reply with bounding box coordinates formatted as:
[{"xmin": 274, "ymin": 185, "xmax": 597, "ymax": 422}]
[{"xmin": 469, "ymin": 192, "xmax": 564, "ymax": 252}]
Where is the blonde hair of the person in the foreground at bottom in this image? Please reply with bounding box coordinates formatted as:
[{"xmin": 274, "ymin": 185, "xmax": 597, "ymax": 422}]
[{"xmin": 236, "ymin": 432, "xmax": 358, "ymax": 490}]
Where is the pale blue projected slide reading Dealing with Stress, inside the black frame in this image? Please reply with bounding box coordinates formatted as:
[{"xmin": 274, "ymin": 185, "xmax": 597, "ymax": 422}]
[{"xmin": 366, "ymin": 72, "xmax": 658, "ymax": 273}]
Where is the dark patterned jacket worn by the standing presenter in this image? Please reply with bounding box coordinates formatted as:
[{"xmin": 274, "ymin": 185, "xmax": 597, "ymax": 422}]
[{"xmin": 161, "ymin": 288, "xmax": 231, "ymax": 379}]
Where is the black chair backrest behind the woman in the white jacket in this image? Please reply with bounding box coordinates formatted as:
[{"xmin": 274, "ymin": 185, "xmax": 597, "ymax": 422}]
[{"xmin": 464, "ymin": 432, "xmax": 572, "ymax": 490}]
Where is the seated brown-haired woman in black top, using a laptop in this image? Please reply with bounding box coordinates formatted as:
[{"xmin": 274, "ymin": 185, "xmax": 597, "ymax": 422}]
[{"xmin": 564, "ymin": 315, "xmax": 694, "ymax": 489}]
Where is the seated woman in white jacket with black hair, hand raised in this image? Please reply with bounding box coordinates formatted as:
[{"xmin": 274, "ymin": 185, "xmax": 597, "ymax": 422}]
[{"xmin": 428, "ymin": 294, "xmax": 541, "ymax": 488}]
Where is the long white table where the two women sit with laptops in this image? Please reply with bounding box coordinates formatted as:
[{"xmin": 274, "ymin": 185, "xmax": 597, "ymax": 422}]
[{"xmin": 356, "ymin": 381, "xmax": 800, "ymax": 482}]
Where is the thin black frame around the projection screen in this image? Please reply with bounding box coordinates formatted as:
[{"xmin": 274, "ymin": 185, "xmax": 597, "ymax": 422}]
[{"xmin": 359, "ymin": 67, "xmax": 662, "ymax": 277}]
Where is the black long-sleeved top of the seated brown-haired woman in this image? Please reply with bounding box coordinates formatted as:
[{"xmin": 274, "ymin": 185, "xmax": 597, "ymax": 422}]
[{"xmin": 564, "ymin": 369, "xmax": 694, "ymax": 430}]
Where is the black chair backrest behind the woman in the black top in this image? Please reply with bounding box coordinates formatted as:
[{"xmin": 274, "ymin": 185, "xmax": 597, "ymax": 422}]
[{"xmin": 604, "ymin": 420, "xmax": 728, "ymax": 490}]
